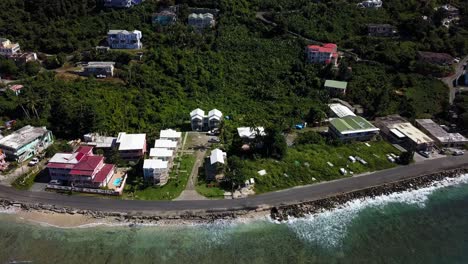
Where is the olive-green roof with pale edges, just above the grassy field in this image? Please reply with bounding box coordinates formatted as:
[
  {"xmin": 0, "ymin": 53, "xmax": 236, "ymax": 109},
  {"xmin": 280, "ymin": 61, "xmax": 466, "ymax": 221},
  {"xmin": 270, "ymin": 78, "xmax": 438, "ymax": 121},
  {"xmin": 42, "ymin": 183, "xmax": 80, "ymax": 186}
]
[{"xmin": 330, "ymin": 116, "xmax": 380, "ymax": 135}]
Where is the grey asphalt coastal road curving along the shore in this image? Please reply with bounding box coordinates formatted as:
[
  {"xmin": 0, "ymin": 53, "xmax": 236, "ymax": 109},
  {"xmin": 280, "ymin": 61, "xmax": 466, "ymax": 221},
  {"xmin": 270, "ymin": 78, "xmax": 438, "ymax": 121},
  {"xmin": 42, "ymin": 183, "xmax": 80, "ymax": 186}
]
[{"xmin": 0, "ymin": 155, "xmax": 468, "ymax": 216}]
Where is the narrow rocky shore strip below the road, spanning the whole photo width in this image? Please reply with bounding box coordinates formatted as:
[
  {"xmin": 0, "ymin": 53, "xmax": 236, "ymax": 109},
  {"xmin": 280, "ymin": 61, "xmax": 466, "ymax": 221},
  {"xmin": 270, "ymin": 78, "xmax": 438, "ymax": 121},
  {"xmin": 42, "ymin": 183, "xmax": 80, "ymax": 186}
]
[{"xmin": 0, "ymin": 168, "xmax": 468, "ymax": 226}]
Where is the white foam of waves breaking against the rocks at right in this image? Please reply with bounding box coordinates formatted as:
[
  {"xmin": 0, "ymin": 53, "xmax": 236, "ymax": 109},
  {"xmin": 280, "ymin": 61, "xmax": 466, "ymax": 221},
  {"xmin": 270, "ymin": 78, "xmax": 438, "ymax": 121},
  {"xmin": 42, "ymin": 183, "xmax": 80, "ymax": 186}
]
[{"xmin": 285, "ymin": 174, "xmax": 468, "ymax": 248}]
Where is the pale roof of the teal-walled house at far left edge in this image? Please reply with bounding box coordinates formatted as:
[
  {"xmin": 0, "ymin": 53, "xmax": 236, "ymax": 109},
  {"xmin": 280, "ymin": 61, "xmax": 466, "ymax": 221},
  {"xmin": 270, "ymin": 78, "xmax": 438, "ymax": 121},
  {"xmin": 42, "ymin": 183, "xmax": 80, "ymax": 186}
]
[{"xmin": 0, "ymin": 125, "xmax": 49, "ymax": 150}]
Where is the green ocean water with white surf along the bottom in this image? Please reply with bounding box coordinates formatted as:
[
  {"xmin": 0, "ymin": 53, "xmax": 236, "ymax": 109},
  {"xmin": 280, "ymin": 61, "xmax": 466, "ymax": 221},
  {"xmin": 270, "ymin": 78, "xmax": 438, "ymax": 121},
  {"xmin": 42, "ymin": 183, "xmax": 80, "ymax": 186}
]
[{"xmin": 0, "ymin": 175, "xmax": 468, "ymax": 264}]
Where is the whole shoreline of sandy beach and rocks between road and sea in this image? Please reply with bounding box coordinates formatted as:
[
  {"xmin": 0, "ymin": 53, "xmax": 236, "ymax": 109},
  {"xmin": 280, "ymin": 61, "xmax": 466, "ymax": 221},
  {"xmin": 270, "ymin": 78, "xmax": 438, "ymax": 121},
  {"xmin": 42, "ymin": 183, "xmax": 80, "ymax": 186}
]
[{"xmin": 0, "ymin": 167, "xmax": 468, "ymax": 228}]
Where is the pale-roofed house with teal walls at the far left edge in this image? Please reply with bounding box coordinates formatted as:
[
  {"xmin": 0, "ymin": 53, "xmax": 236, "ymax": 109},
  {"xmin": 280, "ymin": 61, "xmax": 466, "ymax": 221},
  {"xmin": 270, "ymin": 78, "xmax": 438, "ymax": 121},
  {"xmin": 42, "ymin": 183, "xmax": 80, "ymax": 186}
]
[{"xmin": 0, "ymin": 125, "xmax": 54, "ymax": 162}]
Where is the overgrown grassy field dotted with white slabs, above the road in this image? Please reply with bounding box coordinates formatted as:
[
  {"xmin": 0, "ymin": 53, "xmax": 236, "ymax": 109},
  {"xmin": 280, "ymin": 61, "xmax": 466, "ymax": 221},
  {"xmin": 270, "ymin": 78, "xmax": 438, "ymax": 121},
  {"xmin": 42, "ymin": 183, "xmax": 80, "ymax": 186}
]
[{"xmin": 242, "ymin": 141, "xmax": 400, "ymax": 193}]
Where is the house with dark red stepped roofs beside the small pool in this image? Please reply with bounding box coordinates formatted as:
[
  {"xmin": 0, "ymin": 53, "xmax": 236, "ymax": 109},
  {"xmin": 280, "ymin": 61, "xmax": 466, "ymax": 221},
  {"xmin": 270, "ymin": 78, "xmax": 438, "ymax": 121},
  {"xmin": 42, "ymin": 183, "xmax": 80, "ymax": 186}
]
[{"xmin": 47, "ymin": 146, "xmax": 116, "ymax": 188}]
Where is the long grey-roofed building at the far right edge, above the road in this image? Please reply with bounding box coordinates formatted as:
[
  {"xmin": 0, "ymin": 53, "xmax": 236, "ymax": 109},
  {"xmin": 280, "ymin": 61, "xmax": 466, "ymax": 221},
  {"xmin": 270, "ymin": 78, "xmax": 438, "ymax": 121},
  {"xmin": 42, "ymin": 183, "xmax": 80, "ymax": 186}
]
[{"xmin": 416, "ymin": 119, "xmax": 468, "ymax": 148}]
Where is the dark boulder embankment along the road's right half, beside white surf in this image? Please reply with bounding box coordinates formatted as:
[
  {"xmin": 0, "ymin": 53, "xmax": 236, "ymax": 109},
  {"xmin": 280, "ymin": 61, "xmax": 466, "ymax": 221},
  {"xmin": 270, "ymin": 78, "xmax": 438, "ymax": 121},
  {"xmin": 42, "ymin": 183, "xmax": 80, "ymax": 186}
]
[{"xmin": 270, "ymin": 168, "xmax": 468, "ymax": 221}]
